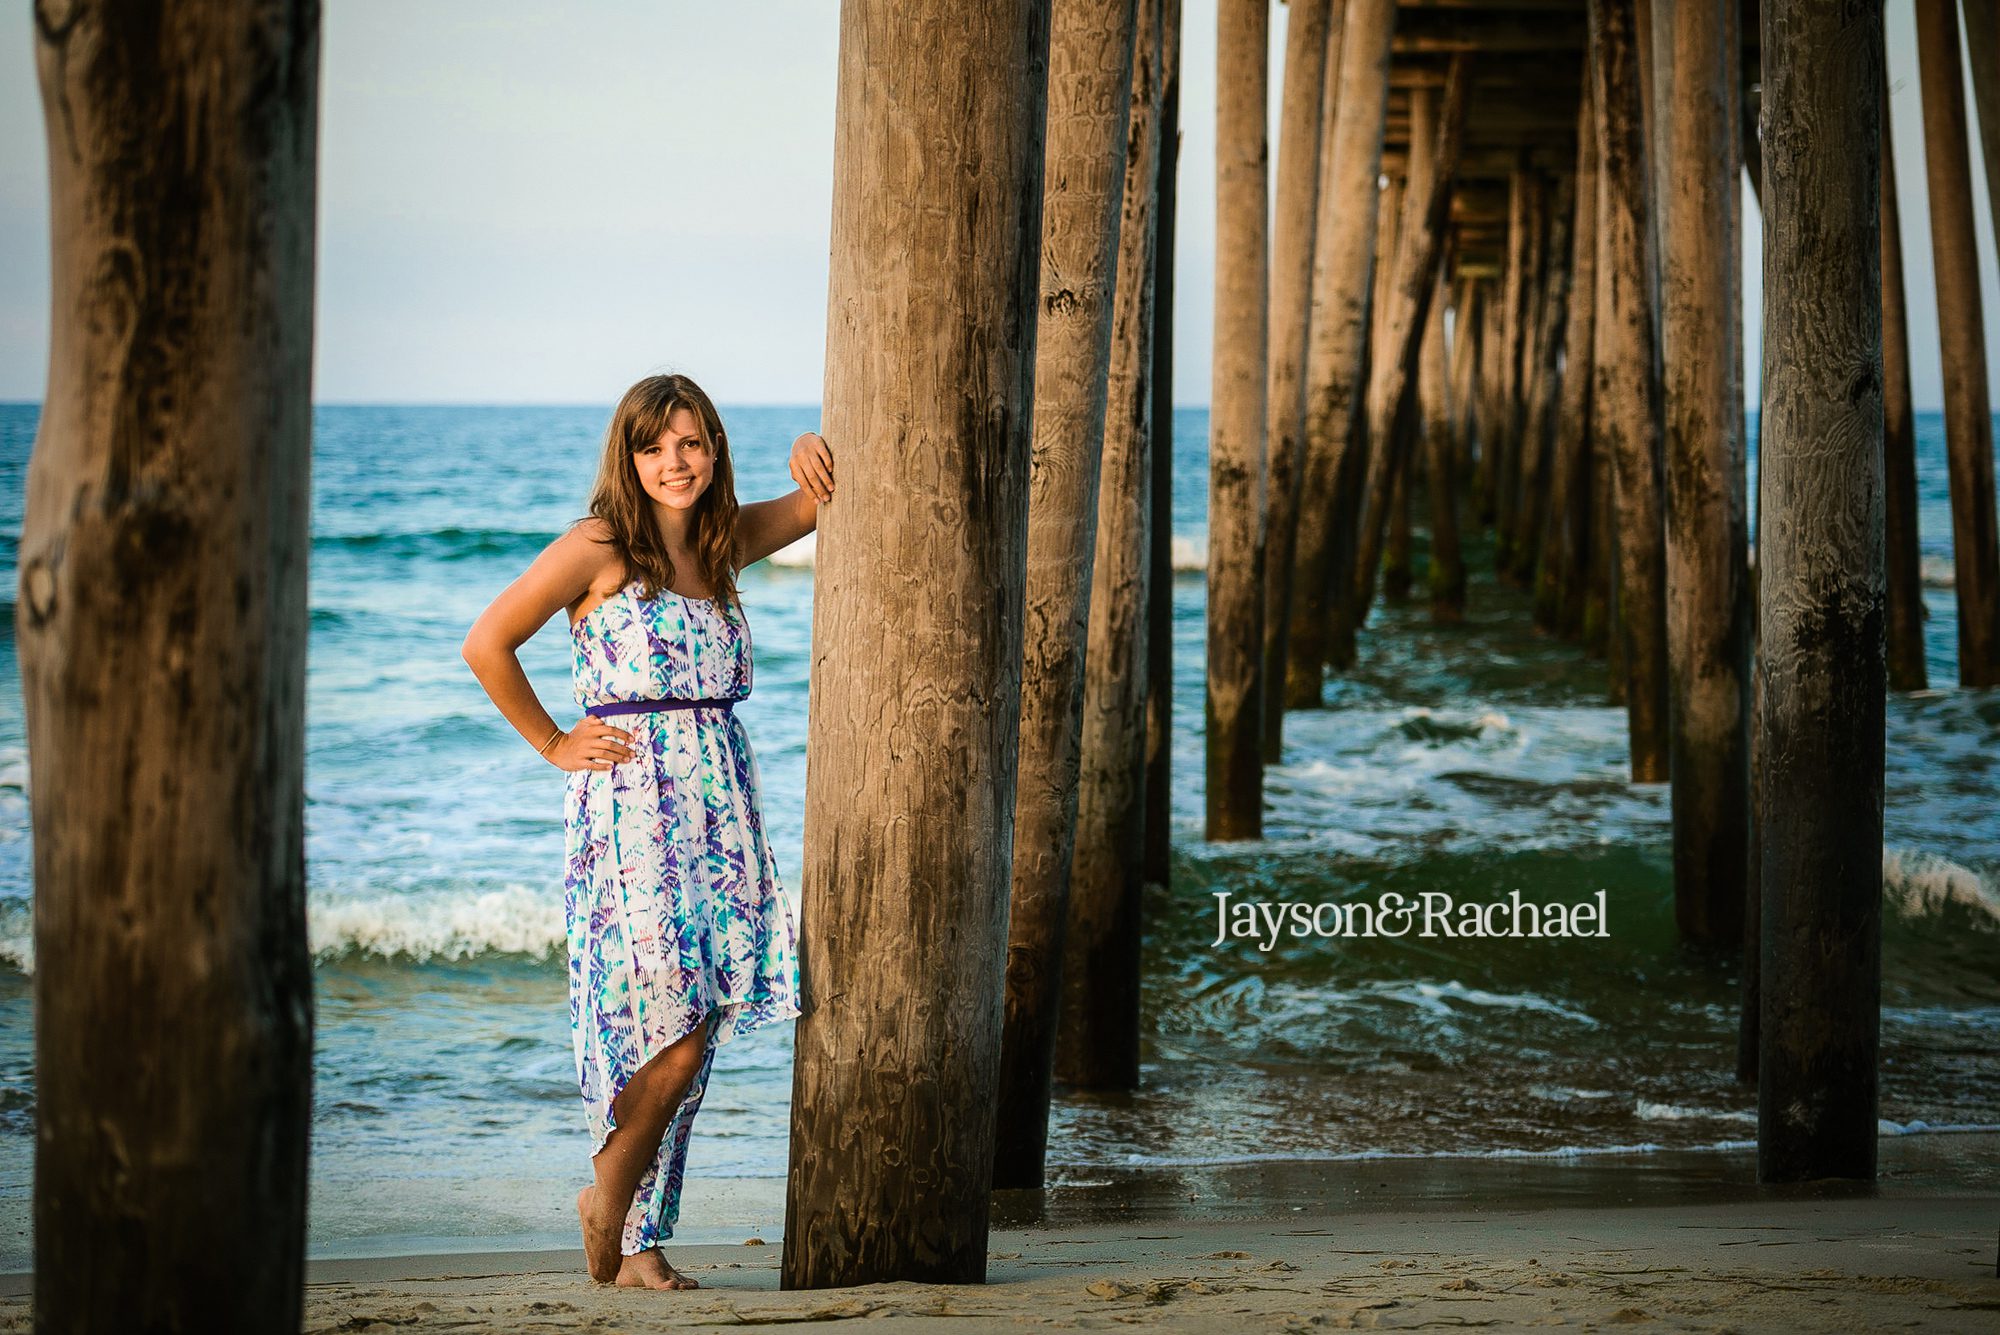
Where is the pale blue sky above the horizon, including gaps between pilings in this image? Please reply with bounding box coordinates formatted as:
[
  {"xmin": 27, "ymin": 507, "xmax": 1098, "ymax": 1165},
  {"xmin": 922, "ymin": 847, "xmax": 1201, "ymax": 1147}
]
[{"xmin": 0, "ymin": 0, "xmax": 2000, "ymax": 410}]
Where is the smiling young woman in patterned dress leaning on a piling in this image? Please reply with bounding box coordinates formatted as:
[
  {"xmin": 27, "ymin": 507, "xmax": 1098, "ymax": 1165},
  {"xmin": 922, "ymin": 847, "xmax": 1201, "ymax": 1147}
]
[{"xmin": 464, "ymin": 376, "xmax": 834, "ymax": 1289}]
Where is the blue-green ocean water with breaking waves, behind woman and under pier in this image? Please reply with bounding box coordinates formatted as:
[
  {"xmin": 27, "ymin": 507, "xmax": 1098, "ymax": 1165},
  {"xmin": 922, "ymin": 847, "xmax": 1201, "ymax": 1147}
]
[{"xmin": 0, "ymin": 395, "xmax": 2000, "ymax": 1269}]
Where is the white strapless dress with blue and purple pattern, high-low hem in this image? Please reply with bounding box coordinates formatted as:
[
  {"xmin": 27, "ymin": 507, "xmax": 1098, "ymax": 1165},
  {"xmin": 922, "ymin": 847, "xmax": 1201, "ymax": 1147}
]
[{"xmin": 564, "ymin": 580, "xmax": 798, "ymax": 1255}]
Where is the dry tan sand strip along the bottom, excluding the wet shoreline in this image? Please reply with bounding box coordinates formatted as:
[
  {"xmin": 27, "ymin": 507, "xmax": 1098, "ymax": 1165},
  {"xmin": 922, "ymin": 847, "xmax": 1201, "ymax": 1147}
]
[{"xmin": 278, "ymin": 1195, "xmax": 2000, "ymax": 1331}]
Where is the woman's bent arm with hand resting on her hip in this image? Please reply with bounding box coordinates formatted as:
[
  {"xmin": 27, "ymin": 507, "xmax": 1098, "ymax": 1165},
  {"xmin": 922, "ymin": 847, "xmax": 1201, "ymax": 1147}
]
[{"xmin": 460, "ymin": 518, "xmax": 626, "ymax": 769}]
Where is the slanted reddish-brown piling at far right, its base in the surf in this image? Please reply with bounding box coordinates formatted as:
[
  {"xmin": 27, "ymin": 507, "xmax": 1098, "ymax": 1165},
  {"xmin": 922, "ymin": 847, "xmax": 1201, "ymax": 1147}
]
[{"xmin": 1904, "ymin": 0, "xmax": 2000, "ymax": 685}]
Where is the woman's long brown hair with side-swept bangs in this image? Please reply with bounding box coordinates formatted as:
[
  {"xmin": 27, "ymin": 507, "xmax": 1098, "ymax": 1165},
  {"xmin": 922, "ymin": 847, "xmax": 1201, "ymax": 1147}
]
[{"xmin": 578, "ymin": 376, "xmax": 740, "ymax": 610}]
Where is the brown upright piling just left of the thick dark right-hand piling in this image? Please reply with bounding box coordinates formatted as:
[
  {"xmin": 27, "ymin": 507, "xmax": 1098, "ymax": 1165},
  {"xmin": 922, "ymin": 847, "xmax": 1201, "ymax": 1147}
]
[{"xmin": 1656, "ymin": 0, "xmax": 1750, "ymax": 953}]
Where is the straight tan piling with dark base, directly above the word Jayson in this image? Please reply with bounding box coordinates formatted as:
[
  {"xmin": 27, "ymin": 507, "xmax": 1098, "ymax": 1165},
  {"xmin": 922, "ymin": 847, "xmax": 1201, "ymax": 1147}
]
[{"xmin": 1202, "ymin": 0, "xmax": 1264, "ymax": 841}]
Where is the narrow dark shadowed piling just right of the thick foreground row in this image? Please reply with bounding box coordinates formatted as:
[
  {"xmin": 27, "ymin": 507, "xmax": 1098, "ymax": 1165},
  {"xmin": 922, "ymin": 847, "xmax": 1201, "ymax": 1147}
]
[{"xmin": 1144, "ymin": 0, "xmax": 1180, "ymax": 887}]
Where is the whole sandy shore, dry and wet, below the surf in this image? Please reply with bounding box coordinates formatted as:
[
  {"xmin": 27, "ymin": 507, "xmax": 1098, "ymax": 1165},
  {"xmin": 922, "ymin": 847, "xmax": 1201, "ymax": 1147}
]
[{"xmin": 0, "ymin": 1133, "xmax": 2000, "ymax": 1333}]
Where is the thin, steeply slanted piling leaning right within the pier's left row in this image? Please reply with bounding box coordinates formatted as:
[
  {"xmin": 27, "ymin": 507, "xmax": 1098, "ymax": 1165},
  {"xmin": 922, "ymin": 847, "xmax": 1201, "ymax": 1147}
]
[{"xmin": 1346, "ymin": 52, "xmax": 1472, "ymax": 643}]
